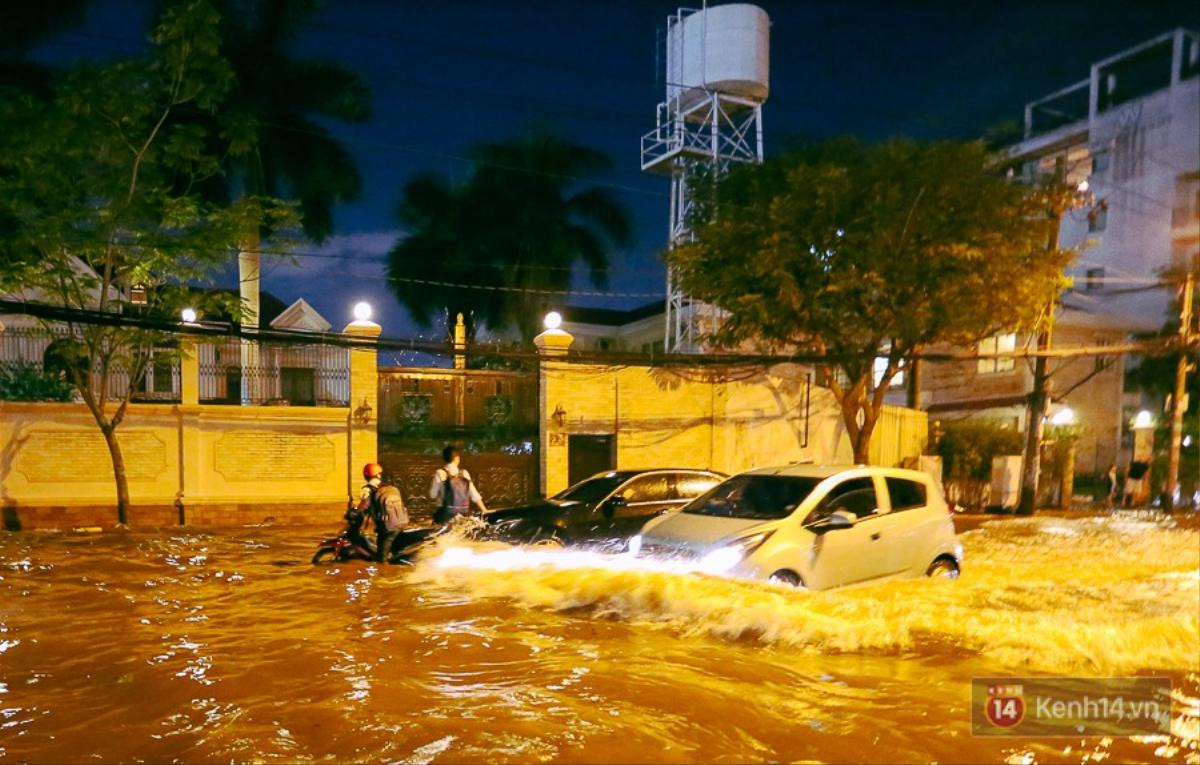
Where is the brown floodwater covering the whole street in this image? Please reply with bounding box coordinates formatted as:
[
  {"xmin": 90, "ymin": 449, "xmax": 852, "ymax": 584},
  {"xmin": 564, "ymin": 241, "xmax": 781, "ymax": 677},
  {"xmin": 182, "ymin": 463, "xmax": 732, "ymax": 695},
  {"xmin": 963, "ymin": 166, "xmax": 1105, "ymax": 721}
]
[{"xmin": 0, "ymin": 517, "xmax": 1200, "ymax": 763}]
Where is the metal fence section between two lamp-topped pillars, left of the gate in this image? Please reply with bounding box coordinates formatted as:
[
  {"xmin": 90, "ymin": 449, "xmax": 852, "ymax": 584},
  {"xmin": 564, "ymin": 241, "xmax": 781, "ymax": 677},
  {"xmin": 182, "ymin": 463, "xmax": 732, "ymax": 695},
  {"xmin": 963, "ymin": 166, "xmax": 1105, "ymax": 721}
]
[{"xmin": 197, "ymin": 338, "xmax": 350, "ymax": 406}]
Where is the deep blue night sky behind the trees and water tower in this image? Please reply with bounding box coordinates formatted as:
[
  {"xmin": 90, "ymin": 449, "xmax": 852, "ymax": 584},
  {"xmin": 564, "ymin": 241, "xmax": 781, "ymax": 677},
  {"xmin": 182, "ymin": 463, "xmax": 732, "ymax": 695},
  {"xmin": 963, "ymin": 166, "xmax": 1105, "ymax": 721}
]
[{"xmin": 37, "ymin": 0, "xmax": 1200, "ymax": 345}]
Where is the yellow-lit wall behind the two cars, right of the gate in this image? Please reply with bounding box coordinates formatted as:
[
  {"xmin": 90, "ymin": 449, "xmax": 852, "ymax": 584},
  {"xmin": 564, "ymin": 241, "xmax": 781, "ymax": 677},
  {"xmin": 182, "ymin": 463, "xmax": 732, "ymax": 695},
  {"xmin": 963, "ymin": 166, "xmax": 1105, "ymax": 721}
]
[{"xmin": 539, "ymin": 357, "xmax": 926, "ymax": 494}]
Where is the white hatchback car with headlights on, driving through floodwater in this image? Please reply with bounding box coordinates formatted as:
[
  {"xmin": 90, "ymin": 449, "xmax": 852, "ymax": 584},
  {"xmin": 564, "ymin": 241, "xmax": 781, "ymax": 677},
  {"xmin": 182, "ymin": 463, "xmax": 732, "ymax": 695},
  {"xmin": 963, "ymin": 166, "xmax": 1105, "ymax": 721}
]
[{"xmin": 629, "ymin": 465, "xmax": 962, "ymax": 590}]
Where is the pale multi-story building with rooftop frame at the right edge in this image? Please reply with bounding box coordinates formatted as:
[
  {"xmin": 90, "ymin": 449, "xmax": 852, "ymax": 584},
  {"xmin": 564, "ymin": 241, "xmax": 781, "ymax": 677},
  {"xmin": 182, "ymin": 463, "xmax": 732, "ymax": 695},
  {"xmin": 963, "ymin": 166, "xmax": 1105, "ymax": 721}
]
[{"xmin": 920, "ymin": 29, "xmax": 1200, "ymax": 472}]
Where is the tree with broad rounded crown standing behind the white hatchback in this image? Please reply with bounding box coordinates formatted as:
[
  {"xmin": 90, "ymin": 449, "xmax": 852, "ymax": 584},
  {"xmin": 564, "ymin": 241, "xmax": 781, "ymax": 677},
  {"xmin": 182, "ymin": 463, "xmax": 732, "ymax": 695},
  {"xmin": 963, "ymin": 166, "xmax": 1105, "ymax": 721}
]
[{"xmin": 667, "ymin": 140, "xmax": 1074, "ymax": 463}]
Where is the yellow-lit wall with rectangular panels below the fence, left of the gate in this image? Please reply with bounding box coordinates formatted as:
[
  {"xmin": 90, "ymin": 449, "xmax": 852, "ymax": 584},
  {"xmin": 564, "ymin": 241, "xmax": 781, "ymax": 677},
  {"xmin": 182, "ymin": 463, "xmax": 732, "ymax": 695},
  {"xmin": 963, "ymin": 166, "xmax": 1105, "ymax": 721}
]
[{"xmin": 0, "ymin": 402, "xmax": 355, "ymax": 529}]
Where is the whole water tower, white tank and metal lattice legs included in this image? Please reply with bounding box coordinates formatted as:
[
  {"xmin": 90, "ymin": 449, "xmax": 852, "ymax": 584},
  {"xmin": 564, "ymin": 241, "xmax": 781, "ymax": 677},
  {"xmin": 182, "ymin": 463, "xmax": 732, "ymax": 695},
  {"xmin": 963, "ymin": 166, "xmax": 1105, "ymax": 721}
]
[{"xmin": 642, "ymin": 4, "xmax": 770, "ymax": 353}]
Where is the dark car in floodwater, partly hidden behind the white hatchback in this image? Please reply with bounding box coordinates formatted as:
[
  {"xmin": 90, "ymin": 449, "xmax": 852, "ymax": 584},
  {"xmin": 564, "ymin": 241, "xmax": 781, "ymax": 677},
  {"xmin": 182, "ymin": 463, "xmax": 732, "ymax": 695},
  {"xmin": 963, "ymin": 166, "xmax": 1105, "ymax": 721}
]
[{"xmin": 484, "ymin": 469, "xmax": 725, "ymax": 546}]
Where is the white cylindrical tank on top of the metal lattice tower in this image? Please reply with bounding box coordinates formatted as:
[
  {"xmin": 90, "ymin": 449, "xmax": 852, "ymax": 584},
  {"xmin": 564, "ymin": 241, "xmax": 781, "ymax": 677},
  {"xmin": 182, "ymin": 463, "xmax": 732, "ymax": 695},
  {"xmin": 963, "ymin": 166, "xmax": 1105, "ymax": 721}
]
[{"xmin": 666, "ymin": 2, "xmax": 770, "ymax": 108}]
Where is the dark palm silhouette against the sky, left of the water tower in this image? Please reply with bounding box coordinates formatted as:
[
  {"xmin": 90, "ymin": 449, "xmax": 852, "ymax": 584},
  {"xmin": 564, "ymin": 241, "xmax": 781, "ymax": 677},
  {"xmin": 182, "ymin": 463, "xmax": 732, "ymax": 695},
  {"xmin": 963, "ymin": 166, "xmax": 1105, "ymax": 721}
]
[{"xmin": 388, "ymin": 135, "xmax": 631, "ymax": 338}]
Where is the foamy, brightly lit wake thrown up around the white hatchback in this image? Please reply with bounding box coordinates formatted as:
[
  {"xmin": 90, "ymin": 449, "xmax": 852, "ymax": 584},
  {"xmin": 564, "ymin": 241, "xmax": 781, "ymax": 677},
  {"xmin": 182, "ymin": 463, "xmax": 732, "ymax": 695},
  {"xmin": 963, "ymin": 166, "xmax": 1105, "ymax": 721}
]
[{"xmin": 414, "ymin": 518, "xmax": 1200, "ymax": 674}]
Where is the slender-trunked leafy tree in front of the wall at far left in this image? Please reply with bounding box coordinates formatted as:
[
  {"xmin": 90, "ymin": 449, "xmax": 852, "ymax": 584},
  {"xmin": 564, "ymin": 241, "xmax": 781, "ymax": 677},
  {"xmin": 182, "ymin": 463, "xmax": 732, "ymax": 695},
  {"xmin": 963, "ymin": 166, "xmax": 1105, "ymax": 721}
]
[{"xmin": 0, "ymin": 0, "xmax": 296, "ymax": 524}]
